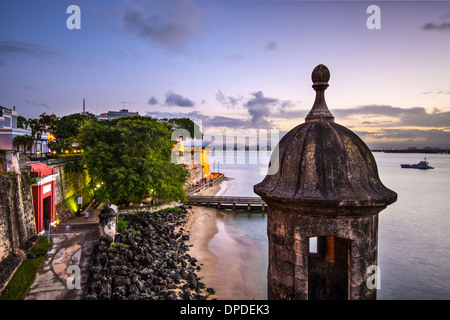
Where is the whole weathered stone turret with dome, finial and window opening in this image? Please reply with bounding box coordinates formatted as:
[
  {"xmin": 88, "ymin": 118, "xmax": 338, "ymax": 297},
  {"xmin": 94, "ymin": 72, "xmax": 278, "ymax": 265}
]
[{"xmin": 254, "ymin": 65, "xmax": 397, "ymax": 299}]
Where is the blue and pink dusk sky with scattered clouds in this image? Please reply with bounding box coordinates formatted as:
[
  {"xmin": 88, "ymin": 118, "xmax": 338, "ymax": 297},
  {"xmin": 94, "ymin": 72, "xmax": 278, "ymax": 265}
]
[{"xmin": 0, "ymin": 0, "xmax": 450, "ymax": 148}]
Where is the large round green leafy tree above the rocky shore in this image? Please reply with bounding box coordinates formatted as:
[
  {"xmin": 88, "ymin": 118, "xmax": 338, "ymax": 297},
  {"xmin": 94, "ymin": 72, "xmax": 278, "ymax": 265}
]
[{"xmin": 78, "ymin": 117, "xmax": 188, "ymax": 204}]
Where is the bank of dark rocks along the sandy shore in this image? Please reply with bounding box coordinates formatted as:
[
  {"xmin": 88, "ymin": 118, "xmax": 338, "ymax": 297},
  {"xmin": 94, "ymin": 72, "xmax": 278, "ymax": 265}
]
[{"xmin": 86, "ymin": 207, "xmax": 214, "ymax": 300}]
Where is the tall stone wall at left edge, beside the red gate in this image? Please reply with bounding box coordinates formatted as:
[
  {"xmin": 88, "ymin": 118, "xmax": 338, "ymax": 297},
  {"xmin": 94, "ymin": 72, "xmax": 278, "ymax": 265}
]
[{"xmin": 0, "ymin": 173, "xmax": 36, "ymax": 262}]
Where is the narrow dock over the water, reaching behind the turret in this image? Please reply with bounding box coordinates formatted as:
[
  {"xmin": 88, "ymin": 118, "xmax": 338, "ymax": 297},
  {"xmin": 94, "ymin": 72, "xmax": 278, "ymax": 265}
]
[{"xmin": 186, "ymin": 196, "xmax": 267, "ymax": 211}]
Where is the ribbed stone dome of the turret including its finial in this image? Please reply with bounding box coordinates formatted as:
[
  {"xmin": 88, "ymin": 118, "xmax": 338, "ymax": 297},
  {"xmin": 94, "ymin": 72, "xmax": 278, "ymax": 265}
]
[{"xmin": 254, "ymin": 64, "xmax": 397, "ymax": 211}]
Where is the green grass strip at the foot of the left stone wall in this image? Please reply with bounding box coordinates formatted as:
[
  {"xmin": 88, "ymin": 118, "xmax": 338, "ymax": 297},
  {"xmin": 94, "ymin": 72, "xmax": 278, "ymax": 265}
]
[{"xmin": 0, "ymin": 237, "xmax": 50, "ymax": 300}]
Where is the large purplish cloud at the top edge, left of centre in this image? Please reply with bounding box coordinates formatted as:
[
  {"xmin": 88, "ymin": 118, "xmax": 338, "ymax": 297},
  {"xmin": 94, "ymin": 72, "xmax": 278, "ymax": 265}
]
[{"xmin": 122, "ymin": 0, "xmax": 204, "ymax": 53}]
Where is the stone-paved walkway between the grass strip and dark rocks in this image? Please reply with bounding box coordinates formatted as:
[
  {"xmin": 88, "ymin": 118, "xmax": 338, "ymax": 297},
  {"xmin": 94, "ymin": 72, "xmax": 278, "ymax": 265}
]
[{"xmin": 25, "ymin": 209, "xmax": 100, "ymax": 300}]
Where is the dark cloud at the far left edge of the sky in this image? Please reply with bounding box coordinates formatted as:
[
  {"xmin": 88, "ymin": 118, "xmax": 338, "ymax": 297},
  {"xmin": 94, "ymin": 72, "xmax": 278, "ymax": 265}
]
[{"xmin": 0, "ymin": 40, "xmax": 65, "ymax": 65}]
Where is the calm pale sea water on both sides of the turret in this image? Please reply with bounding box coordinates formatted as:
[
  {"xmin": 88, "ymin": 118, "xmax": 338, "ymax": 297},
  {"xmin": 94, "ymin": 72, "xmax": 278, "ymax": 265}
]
[{"xmin": 210, "ymin": 151, "xmax": 450, "ymax": 300}]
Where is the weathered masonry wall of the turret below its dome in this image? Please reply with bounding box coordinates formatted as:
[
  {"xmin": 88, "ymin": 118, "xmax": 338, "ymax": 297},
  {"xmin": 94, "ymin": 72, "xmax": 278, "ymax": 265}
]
[{"xmin": 267, "ymin": 203, "xmax": 381, "ymax": 300}]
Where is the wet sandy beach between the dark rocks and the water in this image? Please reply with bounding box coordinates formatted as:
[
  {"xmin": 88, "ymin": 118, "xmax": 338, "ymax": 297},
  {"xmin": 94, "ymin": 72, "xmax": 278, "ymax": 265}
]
[{"xmin": 186, "ymin": 185, "xmax": 265, "ymax": 300}]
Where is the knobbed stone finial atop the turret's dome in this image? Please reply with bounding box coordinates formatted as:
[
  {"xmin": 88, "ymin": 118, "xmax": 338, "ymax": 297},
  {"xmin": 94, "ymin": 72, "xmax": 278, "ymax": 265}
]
[{"xmin": 305, "ymin": 64, "xmax": 334, "ymax": 122}]
